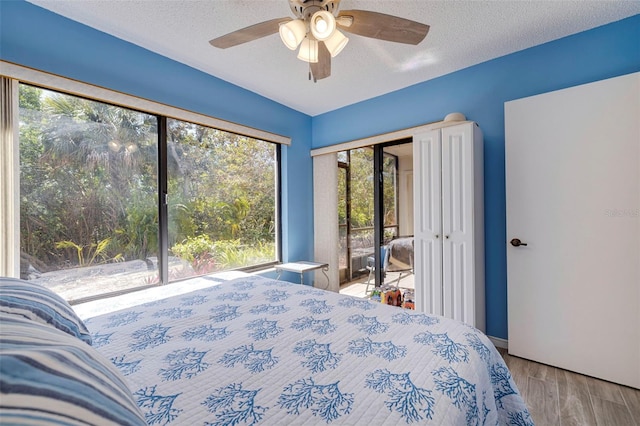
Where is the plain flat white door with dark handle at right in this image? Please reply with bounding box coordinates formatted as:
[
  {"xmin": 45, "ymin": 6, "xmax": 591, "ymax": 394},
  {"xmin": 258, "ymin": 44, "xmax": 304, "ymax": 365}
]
[{"xmin": 505, "ymin": 73, "xmax": 640, "ymax": 387}]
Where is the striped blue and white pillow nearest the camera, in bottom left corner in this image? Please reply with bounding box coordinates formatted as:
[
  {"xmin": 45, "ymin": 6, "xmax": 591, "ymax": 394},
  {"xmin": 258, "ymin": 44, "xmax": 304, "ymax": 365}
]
[{"xmin": 0, "ymin": 313, "xmax": 146, "ymax": 425}]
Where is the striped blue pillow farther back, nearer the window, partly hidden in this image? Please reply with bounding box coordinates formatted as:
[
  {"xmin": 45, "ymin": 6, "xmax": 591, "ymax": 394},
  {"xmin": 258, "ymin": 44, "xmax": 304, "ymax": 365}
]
[{"xmin": 0, "ymin": 277, "xmax": 91, "ymax": 344}]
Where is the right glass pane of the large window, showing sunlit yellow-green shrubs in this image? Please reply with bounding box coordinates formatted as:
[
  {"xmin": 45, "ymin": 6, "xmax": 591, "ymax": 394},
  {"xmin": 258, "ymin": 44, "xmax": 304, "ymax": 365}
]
[{"xmin": 167, "ymin": 120, "xmax": 278, "ymax": 280}]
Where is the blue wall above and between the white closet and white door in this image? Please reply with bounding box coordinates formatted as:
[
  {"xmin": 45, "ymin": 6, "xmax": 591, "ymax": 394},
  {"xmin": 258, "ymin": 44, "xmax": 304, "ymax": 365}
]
[{"xmin": 312, "ymin": 15, "xmax": 640, "ymax": 339}]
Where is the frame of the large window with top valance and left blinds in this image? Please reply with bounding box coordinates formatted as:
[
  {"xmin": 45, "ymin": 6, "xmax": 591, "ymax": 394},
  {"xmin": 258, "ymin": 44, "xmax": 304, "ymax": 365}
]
[{"xmin": 0, "ymin": 61, "xmax": 284, "ymax": 303}]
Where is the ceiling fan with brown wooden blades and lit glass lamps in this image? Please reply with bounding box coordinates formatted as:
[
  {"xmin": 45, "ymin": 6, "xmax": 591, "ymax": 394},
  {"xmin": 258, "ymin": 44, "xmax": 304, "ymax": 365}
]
[{"xmin": 209, "ymin": 0, "xmax": 429, "ymax": 81}]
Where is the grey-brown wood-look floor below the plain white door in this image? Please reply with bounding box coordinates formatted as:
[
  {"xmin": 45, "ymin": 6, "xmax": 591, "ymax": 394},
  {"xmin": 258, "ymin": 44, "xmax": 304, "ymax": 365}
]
[{"xmin": 500, "ymin": 349, "xmax": 640, "ymax": 426}]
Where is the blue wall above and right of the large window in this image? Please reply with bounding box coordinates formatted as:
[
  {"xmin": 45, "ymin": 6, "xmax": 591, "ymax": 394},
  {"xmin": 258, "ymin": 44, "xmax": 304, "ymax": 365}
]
[{"xmin": 0, "ymin": 1, "xmax": 313, "ymax": 261}]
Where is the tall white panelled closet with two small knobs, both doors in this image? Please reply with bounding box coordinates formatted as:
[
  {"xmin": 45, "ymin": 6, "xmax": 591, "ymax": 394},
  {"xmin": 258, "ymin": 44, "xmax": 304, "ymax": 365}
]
[{"xmin": 413, "ymin": 122, "xmax": 485, "ymax": 331}]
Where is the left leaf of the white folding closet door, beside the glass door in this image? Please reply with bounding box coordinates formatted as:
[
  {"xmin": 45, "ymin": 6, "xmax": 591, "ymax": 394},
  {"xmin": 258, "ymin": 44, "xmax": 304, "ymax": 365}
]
[{"xmin": 413, "ymin": 130, "xmax": 443, "ymax": 315}]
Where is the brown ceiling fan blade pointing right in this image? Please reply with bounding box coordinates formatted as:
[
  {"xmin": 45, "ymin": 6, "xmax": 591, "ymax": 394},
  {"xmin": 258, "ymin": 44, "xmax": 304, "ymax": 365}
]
[{"xmin": 337, "ymin": 10, "xmax": 429, "ymax": 44}]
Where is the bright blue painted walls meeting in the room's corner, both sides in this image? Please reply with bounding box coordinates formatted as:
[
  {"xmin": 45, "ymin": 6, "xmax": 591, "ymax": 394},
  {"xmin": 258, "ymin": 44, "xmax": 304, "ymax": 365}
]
[{"xmin": 0, "ymin": 1, "xmax": 640, "ymax": 338}]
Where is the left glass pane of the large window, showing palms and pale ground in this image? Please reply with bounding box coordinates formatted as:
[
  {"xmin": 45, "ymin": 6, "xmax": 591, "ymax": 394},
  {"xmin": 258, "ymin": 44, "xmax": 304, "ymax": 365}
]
[{"xmin": 19, "ymin": 85, "xmax": 158, "ymax": 300}]
